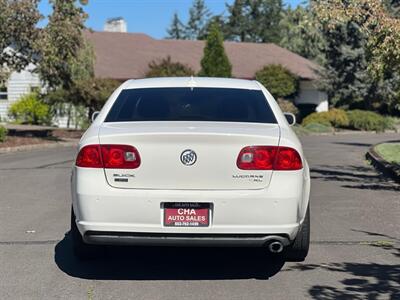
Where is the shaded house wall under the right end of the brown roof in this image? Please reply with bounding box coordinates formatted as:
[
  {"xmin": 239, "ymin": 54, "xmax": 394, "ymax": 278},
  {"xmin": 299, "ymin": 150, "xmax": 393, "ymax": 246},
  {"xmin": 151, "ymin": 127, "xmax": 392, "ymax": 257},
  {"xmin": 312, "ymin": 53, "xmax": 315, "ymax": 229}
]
[{"xmin": 295, "ymin": 80, "xmax": 328, "ymax": 111}]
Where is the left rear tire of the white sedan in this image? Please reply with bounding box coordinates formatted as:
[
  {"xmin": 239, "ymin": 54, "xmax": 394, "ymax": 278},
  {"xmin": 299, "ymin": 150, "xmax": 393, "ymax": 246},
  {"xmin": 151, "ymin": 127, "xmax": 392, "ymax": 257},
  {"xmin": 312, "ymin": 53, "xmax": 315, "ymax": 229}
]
[{"xmin": 70, "ymin": 209, "xmax": 100, "ymax": 260}]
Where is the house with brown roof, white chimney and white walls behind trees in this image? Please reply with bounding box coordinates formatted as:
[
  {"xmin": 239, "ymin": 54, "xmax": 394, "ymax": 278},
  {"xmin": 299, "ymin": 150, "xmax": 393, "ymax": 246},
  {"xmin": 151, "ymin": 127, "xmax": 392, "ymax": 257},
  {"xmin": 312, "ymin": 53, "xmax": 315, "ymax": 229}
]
[{"xmin": 0, "ymin": 18, "xmax": 328, "ymax": 127}]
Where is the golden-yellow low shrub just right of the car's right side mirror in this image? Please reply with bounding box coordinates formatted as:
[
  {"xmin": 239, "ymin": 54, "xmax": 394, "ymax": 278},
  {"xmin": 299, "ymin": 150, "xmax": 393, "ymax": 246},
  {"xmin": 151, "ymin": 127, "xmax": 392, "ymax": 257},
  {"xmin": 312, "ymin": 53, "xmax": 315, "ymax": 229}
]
[{"xmin": 301, "ymin": 108, "xmax": 349, "ymax": 128}]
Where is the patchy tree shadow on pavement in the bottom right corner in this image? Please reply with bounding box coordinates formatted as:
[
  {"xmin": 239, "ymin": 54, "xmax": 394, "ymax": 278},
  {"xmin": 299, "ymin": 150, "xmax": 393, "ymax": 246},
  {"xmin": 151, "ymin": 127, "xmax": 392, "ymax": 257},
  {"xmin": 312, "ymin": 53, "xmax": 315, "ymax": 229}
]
[{"xmin": 285, "ymin": 230, "xmax": 400, "ymax": 300}]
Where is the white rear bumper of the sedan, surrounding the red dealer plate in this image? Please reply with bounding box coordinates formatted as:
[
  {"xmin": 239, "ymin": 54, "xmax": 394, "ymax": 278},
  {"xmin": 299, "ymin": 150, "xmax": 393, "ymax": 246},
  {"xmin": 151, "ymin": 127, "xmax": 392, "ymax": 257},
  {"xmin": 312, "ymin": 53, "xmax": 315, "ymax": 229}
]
[{"xmin": 72, "ymin": 168, "xmax": 309, "ymax": 246}]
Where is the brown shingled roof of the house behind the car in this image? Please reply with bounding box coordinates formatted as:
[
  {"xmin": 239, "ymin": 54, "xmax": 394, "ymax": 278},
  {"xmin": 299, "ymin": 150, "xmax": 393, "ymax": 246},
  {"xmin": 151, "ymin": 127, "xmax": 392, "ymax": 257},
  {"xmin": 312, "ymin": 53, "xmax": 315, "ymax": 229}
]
[{"xmin": 85, "ymin": 31, "xmax": 318, "ymax": 80}]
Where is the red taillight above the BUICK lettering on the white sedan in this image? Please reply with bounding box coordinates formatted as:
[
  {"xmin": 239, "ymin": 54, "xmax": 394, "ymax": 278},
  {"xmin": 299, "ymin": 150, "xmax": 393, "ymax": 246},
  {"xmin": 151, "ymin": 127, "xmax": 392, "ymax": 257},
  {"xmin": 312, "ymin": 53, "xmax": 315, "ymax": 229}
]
[{"xmin": 75, "ymin": 145, "xmax": 140, "ymax": 169}]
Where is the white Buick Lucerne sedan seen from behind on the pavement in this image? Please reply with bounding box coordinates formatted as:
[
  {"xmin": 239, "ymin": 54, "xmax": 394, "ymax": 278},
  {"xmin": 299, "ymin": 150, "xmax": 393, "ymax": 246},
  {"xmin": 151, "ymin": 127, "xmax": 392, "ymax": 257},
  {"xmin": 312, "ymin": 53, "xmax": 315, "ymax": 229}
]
[{"xmin": 71, "ymin": 77, "xmax": 310, "ymax": 261}]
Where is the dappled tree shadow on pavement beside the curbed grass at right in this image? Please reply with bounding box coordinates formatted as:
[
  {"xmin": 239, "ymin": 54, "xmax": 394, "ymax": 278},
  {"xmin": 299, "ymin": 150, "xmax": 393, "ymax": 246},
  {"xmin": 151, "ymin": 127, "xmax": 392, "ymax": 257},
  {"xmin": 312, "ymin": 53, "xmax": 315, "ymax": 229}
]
[{"xmin": 311, "ymin": 165, "xmax": 400, "ymax": 191}]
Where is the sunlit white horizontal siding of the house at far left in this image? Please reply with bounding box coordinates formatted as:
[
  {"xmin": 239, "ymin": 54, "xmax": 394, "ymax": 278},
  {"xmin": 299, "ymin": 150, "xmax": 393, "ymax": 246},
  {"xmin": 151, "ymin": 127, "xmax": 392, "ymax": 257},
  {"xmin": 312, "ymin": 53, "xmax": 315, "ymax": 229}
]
[{"xmin": 0, "ymin": 65, "xmax": 41, "ymax": 120}]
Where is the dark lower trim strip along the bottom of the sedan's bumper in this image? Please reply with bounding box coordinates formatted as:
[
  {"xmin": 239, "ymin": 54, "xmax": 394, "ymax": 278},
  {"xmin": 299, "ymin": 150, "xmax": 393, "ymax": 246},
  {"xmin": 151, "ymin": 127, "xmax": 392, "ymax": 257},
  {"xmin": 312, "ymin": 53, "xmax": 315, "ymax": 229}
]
[{"xmin": 83, "ymin": 231, "xmax": 290, "ymax": 247}]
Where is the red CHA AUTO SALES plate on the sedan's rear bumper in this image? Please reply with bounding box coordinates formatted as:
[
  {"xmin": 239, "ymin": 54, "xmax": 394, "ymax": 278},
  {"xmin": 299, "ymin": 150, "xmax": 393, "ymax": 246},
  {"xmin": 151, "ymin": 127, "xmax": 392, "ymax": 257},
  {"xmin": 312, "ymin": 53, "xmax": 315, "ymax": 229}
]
[{"xmin": 164, "ymin": 203, "xmax": 210, "ymax": 227}]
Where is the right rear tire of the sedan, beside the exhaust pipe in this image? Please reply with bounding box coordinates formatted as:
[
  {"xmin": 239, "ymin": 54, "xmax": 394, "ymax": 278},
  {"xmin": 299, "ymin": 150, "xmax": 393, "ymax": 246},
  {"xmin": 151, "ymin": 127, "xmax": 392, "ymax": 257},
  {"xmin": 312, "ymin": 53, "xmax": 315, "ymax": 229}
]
[{"xmin": 285, "ymin": 206, "xmax": 310, "ymax": 262}]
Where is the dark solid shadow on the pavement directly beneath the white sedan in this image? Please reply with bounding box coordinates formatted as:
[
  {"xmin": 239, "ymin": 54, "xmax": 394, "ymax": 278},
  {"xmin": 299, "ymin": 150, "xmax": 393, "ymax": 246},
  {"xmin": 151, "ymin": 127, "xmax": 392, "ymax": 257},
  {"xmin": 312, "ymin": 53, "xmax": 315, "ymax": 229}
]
[{"xmin": 55, "ymin": 233, "xmax": 284, "ymax": 280}]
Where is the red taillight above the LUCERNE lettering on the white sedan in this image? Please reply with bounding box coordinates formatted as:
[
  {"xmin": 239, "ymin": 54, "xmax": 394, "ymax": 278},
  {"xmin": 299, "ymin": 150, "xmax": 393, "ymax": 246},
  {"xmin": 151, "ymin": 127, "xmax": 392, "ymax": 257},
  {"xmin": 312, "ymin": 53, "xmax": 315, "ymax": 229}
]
[{"xmin": 236, "ymin": 146, "xmax": 303, "ymax": 170}]
